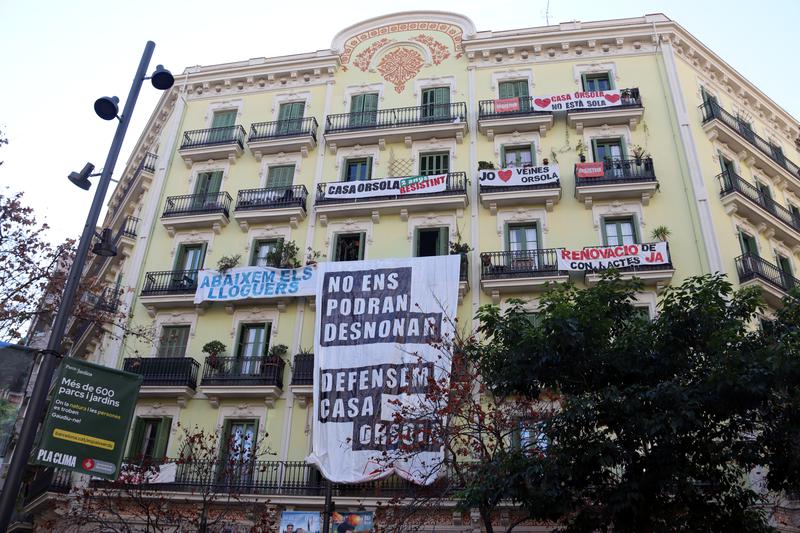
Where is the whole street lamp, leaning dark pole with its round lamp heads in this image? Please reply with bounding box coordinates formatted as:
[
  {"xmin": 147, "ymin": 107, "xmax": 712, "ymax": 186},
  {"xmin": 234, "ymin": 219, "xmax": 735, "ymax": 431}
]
[{"xmin": 0, "ymin": 41, "xmax": 175, "ymax": 531}]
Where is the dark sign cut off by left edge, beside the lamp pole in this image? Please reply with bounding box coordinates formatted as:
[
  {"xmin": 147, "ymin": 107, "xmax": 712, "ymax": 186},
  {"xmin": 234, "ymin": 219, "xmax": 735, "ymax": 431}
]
[{"xmin": 0, "ymin": 342, "xmax": 36, "ymax": 464}]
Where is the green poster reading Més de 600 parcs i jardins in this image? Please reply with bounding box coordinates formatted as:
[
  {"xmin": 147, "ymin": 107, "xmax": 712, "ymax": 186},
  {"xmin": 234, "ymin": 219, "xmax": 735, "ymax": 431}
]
[{"xmin": 33, "ymin": 358, "xmax": 142, "ymax": 480}]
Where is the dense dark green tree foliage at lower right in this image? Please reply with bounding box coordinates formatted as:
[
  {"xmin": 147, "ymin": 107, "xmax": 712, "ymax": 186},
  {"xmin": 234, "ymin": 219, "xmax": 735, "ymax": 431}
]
[{"xmin": 472, "ymin": 273, "xmax": 800, "ymax": 532}]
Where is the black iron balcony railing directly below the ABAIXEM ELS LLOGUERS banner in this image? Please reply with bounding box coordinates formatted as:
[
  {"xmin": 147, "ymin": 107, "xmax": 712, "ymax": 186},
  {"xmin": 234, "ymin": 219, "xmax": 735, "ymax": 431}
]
[{"xmin": 203, "ymin": 357, "xmax": 286, "ymax": 388}]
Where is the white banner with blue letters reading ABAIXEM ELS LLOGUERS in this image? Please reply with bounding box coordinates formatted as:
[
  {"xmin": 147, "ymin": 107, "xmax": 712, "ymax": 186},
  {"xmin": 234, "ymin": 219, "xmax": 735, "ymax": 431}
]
[{"xmin": 194, "ymin": 265, "xmax": 317, "ymax": 304}]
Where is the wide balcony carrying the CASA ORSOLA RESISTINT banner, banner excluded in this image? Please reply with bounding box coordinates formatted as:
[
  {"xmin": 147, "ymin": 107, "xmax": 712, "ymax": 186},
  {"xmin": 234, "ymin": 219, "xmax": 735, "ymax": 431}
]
[{"xmin": 314, "ymin": 172, "xmax": 469, "ymax": 226}]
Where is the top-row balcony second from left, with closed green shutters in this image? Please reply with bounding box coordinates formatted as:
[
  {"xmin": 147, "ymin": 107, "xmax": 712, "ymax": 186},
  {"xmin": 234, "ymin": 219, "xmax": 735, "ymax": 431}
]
[{"xmin": 247, "ymin": 117, "xmax": 318, "ymax": 161}]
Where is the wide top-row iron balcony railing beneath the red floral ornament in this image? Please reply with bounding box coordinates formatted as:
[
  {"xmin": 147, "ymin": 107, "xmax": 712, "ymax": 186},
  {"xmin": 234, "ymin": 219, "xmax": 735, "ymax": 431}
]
[{"xmin": 325, "ymin": 102, "xmax": 467, "ymax": 133}]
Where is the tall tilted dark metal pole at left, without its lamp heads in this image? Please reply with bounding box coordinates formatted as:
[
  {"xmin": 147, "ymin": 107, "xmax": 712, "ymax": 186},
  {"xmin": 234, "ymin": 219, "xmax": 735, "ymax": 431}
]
[{"xmin": 0, "ymin": 41, "xmax": 156, "ymax": 532}]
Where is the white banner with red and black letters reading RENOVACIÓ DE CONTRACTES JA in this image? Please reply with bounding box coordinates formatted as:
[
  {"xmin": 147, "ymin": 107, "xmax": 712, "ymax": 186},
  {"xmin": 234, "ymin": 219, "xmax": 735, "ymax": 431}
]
[{"xmin": 558, "ymin": 242, "xmax": 669, "ymax": 270}]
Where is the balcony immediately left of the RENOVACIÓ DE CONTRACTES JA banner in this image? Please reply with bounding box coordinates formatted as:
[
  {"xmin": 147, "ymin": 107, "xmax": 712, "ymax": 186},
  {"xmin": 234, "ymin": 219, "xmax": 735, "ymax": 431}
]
[{"xmin": 481, "ymin": 248, "xmax": 569, "ymax": 304}]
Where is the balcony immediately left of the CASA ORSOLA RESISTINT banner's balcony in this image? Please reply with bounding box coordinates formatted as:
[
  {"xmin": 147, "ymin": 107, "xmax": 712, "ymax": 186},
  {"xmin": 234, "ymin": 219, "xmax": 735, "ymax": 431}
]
[{"xmin": 235, "ymin": 185, "xmax": 308, "ymax": 232}]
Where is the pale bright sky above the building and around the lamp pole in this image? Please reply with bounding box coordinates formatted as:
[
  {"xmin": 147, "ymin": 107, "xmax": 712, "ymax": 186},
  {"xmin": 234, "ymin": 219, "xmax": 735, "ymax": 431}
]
[{"xmin": 0, "ymin": 0, "xmax": 800, "ymax": 241}]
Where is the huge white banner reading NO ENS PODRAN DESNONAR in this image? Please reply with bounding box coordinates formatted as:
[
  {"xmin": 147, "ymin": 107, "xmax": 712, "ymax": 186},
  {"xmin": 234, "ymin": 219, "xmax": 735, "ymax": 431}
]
[{"xmin": 307, "ymin": 255, "xmax": 461, "ymax": 484}]
